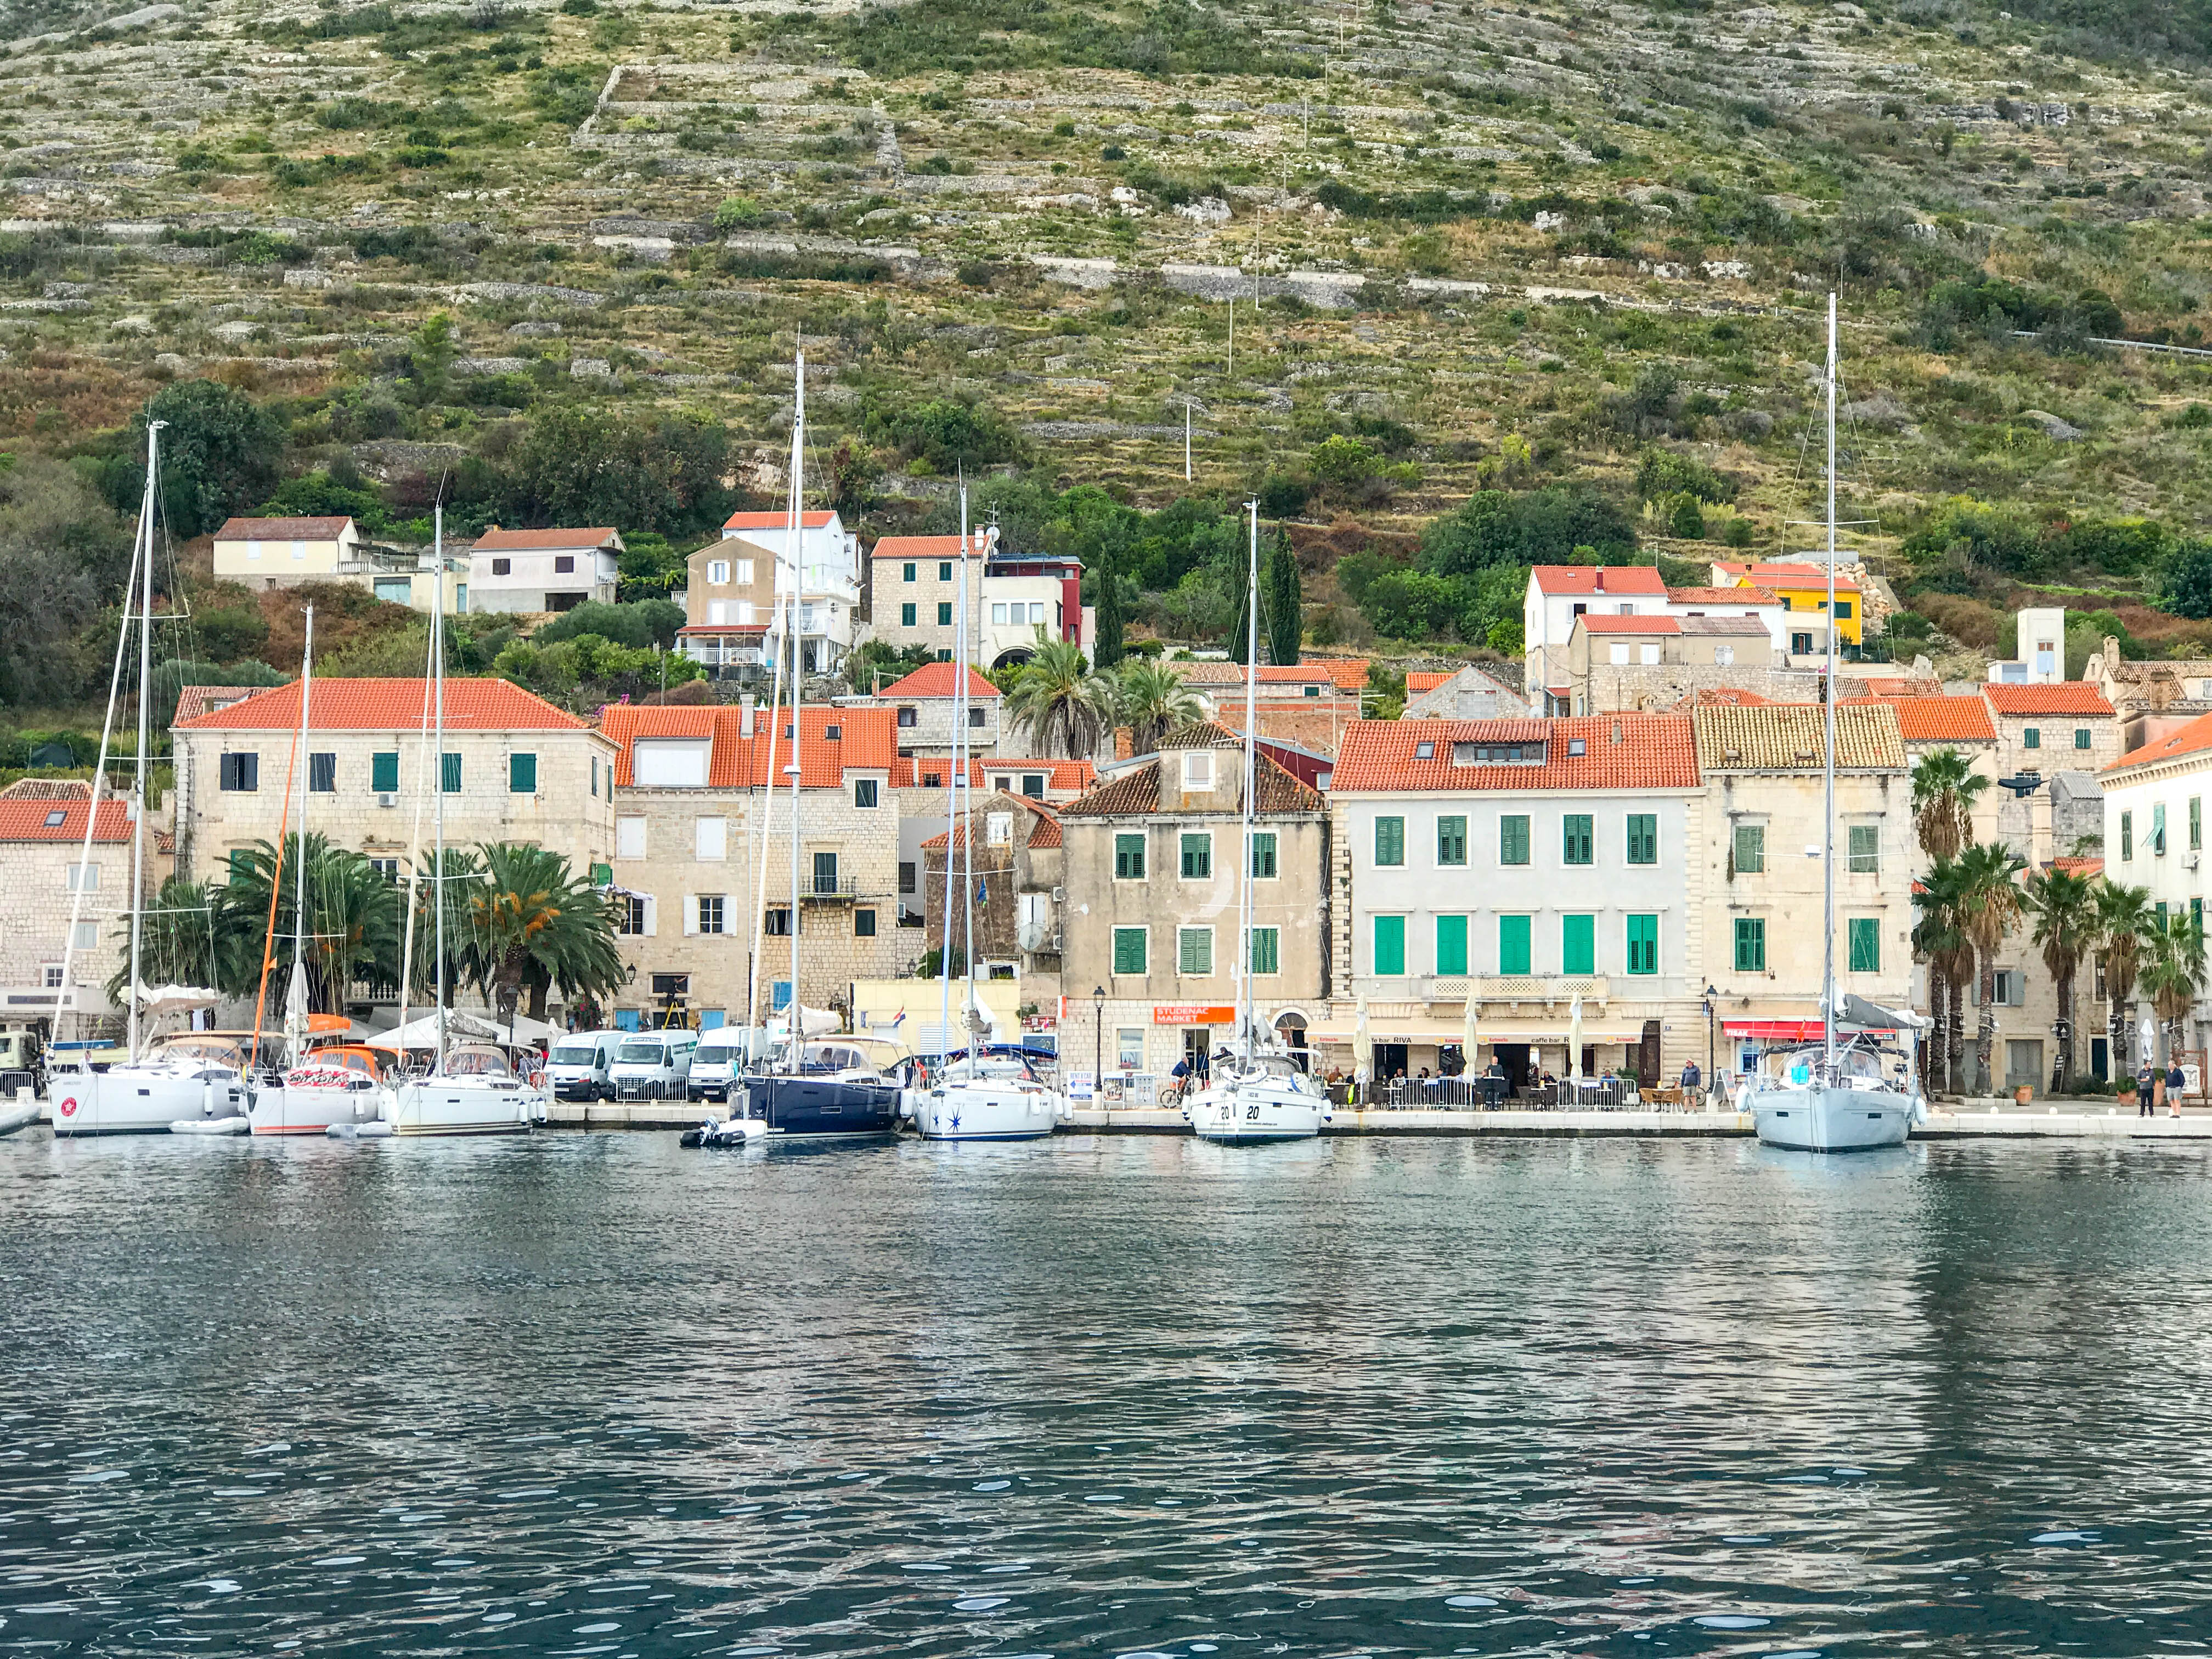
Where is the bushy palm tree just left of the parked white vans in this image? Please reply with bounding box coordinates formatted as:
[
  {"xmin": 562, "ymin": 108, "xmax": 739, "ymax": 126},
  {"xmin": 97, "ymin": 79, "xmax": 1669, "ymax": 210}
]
[{"xmin": 465, "ymin": 840, "xmax": 622, "ymax": 1020}]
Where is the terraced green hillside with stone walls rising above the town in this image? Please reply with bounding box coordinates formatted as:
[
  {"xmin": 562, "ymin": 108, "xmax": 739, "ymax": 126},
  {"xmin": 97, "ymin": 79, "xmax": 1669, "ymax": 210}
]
[{"xmin": 0, "ymin": 0, "xmax": 2212, "ymax": 721}]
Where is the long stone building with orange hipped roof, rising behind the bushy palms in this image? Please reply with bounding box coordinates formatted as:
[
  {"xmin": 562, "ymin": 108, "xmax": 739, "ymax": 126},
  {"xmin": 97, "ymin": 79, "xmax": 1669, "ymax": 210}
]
[{"xmin": 170, "ymin": 679, "xmax": 615, "ymax": 881}]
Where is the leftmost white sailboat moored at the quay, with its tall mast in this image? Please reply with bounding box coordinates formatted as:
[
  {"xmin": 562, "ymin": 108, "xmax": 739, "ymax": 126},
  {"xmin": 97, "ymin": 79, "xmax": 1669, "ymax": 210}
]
[{"xmin": 47, "ymin": 420, "xmax": 246, "ymax": 1137}]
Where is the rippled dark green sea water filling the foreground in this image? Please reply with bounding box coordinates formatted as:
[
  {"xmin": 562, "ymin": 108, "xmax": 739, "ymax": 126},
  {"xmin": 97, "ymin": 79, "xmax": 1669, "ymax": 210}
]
[{"xmin": 0, "ymin": 1130, "xmax": 2212, "ymax": 1659}]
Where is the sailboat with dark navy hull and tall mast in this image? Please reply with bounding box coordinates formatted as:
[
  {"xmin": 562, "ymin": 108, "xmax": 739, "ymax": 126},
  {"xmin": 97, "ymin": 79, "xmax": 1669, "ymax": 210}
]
[{"xmin": 681, "ymin": 347, "xmax": 900, "ymax": 1148}]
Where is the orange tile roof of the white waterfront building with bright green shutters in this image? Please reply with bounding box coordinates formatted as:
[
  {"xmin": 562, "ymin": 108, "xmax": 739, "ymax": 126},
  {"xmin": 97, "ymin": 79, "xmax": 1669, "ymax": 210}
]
[{"xmin": 1329, "ymin": 714, "xmax": 1699, "ymax": 794}]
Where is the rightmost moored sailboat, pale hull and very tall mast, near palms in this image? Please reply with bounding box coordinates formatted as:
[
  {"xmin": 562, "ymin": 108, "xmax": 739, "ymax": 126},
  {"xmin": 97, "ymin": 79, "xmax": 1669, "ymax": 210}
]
[{"xmin": 1745, "ymin": 294, "xmax": 1918, "ymax": 1153}]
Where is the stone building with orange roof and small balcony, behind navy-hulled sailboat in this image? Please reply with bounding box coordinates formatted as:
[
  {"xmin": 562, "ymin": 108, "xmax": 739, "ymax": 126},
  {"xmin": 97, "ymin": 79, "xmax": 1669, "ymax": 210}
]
[{"xmin": 604, "ymin": 703, "xmax": 902, "ymax": 1029}]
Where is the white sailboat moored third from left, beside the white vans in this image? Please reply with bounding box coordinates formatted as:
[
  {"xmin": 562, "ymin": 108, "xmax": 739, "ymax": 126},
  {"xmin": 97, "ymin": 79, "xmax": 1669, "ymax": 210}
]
[{"xmin": 381, "ymin": 506, "xmax": 546, "ymax": 1135}]
